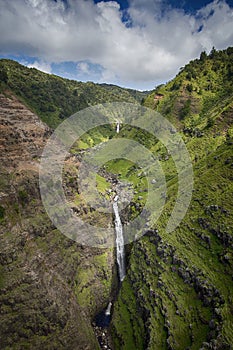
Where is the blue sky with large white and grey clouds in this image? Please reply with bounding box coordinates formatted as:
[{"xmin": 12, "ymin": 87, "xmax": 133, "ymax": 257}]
[{"xmin": 0, "ymin": 0, "xmax": 233, "ymax": 90}]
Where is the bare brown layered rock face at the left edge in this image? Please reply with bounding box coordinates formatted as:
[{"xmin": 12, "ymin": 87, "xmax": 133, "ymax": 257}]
[{"xmin": 0, "ymin": 93, "xmax": 51, "ymax": 170}]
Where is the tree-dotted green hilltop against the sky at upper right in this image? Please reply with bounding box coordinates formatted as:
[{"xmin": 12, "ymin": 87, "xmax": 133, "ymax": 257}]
[{"xmin": 145, "ymin": 47, "xmax": 233, "ymax": 126}]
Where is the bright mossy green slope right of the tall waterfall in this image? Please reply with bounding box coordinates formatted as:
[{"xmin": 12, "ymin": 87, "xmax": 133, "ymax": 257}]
[{"xmin": 112, "ymin": 48, "xmax": 233, "ymax": 350}]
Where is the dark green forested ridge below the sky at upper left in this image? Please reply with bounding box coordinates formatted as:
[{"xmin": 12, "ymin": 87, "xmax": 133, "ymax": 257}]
[{"xmin": 0, "ymin": 59, "xmax": 146, "ymax": 128}]
